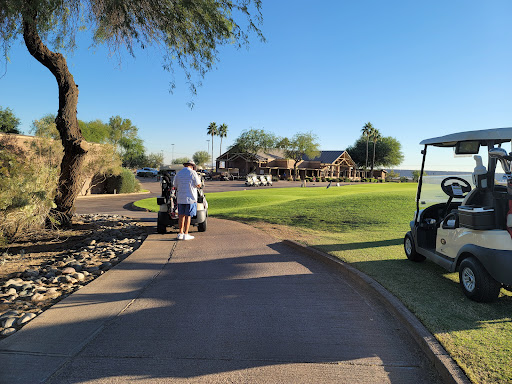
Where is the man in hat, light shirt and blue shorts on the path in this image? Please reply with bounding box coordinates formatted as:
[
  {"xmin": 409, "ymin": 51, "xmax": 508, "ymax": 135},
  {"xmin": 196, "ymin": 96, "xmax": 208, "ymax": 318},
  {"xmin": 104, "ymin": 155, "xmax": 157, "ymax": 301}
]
[{"xmin": 174, "ymin": 160, "xmax": 201, "ymax": 240}]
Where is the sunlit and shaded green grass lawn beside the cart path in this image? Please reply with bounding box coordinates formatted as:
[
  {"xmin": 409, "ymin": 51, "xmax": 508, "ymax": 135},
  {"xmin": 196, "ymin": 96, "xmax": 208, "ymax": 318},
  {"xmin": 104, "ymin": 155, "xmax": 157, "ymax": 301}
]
[{"xmin": 137, "ymin": 183, "xmax": 512, "ymax": 383}]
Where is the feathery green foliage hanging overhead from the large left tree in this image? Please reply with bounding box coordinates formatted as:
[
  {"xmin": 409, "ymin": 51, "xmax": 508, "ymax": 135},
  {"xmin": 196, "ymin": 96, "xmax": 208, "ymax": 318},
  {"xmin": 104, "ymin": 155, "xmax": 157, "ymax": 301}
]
[{"xmin": 0, "ymin": 0, "xmax": 264, "ymax": 92}]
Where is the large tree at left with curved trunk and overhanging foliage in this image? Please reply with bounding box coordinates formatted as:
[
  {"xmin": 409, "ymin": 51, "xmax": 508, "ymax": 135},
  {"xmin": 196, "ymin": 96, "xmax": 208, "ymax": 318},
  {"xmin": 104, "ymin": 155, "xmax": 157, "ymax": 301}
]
[{"xmin": 0, "ymin": 0, "xmax": 263, "ymax": 224}]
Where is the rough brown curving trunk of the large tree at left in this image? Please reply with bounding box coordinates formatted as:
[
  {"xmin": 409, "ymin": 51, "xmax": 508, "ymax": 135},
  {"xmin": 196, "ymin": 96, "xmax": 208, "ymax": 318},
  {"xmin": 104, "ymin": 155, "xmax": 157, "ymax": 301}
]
[{"xmin": 23, "ymin": 11, "xmax": 87, "ymax": 226}]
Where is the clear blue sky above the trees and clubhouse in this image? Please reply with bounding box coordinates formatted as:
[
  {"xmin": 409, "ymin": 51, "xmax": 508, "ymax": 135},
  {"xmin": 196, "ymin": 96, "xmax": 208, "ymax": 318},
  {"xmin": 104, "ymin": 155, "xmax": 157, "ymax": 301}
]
[{"xmin": 0, "ymin": 0, "xmax": 512, "ymax": 169}]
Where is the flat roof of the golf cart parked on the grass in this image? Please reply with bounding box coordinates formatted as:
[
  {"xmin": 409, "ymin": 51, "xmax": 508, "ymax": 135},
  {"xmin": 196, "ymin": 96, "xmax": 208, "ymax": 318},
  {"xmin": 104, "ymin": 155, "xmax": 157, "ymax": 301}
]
[{"xmin": 420, "ymin": 128, "xmax": 512, "ymax": 147}]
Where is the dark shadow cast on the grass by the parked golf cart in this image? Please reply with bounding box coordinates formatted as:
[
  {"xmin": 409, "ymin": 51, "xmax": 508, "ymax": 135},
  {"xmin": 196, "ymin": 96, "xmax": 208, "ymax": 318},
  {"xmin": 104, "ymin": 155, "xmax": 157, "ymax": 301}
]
[{"xmin": 315, "ymin": 243, "xmax": 512, "ymax": 337}]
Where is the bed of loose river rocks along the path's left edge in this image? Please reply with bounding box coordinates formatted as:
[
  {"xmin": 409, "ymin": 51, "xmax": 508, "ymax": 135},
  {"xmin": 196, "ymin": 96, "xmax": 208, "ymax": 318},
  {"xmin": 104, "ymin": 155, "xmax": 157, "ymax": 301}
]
[{"xmin": 0, "ymin": 215, "xmax": 148, "ymax": 339}]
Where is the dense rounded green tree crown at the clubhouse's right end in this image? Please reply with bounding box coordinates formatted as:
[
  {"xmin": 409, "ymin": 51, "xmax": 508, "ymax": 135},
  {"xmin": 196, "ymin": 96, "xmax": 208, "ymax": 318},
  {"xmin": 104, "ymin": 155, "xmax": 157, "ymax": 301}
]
[{"xmin": 347, "ymin": 136, "xmax": 404, "ymax": 167}]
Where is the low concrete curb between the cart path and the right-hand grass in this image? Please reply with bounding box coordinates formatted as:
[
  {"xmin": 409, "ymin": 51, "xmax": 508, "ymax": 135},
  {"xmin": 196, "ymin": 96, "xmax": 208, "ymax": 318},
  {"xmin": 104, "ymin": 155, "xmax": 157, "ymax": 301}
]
[{"xmin": 283, "ymin": 240, "xmax": 471, "ymax": 384}]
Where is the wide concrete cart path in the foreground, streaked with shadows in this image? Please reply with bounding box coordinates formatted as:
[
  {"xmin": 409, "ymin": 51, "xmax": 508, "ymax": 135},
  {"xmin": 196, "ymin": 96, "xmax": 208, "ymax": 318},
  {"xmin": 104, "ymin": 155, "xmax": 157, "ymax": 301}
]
[{"xmin": 0, "ymin": 219, "xmax": 440, "ymax": 384}]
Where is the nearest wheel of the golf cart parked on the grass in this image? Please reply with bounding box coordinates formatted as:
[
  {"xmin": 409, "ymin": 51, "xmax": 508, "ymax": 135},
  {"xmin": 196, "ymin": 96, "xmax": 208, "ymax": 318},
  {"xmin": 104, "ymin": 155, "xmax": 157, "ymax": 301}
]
[{"xmin": 459, "ymin": 257, "xmax": 501, "ymax": 303}]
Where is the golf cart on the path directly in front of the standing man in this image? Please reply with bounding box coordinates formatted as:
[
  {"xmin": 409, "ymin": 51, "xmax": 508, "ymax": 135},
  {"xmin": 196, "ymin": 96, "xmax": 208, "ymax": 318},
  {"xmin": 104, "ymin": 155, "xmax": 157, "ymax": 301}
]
[{"xmin": 156, "ymin": 165, "xmax": 208, "ymax": 233}]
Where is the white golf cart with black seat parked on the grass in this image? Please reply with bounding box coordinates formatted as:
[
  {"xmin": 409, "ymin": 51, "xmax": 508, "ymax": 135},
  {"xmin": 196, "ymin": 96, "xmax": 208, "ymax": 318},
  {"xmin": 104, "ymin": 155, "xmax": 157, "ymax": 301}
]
[{"xmin": 404, "ymin": 128, "xmax": 512, "ymax": 302}]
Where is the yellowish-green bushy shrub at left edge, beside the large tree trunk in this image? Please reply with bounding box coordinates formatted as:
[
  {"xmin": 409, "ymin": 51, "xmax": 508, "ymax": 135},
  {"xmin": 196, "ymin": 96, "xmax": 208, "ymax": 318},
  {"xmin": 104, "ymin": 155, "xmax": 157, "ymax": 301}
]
[{"xmin": 0, "ymin": 138, "xmax": 59, "ymax": 245}]
